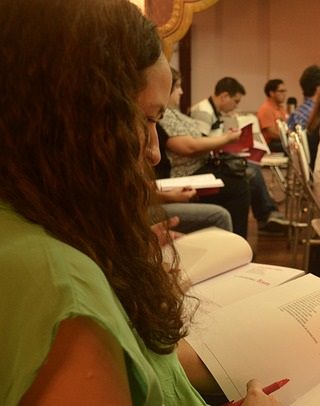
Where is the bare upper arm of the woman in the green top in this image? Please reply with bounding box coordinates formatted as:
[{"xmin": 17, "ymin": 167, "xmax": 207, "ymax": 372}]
[{"xmin": 21, "ymin": 317, "xmax": 131, "ymax": 406}]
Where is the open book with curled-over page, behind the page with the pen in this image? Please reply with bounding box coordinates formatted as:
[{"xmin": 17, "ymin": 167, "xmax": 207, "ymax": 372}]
[{"xmin": 175, "ymin": 227, "xmax": 304, "ymax": 308}]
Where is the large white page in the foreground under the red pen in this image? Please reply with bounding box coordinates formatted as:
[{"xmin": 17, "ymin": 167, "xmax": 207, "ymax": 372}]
[{"xmin": 188, "ymin": 274, "xmax": 320, "ymax": 405}]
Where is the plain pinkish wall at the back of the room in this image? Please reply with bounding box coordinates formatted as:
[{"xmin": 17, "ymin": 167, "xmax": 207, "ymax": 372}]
[{"xmin": 192, "ymin": 0, "xmax": 320, "ymax": 111}]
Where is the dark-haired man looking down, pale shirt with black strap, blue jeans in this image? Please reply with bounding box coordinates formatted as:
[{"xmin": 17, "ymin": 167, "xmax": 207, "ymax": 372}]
[{"xmin": 191, "ymin": 77, "xmax": 288, "ymax": 234}]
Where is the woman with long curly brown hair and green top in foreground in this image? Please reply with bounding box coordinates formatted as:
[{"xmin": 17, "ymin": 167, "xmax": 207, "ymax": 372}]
[{"xmin": 0, "ymin": 0, "xmax": 280, "ymax": 406}]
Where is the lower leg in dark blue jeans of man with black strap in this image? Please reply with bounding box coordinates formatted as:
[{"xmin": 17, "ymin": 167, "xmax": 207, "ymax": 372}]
[{"xmin": 247, "ymin": 162, "xmax": 278, "ymax": 221}]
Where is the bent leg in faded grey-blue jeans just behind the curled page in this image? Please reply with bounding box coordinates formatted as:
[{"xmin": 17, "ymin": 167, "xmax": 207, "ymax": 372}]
[{"xmin": 162, "ymin": 203, "xmax": 232, "ymax": 233}]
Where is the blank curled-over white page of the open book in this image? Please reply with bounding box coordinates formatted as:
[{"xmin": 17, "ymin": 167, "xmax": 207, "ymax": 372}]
[{"xmin": 175, "ymin": 227, "xmax": 252, "ymax": 284}]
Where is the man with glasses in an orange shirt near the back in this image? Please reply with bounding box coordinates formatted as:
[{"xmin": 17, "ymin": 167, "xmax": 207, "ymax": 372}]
[{"xmin": 257, "ymin": 79, "xmax": 287, "ymax": 152}]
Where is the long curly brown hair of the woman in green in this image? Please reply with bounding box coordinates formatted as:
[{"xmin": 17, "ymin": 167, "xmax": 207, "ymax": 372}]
[{"xmin": 0, "ymin": 0, "xmax": 190, "ymax": 353}]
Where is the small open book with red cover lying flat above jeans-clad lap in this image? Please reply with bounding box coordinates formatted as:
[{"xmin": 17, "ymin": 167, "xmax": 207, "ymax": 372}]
[{"xmin": 156, "ymin": 173, "xmax": 224, "ymax": 195}]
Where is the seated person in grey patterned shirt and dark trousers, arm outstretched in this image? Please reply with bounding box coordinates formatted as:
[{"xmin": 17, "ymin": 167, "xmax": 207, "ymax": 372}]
[{"xmin": 160, "ymin": 69, "xmax": 250, "ymax": 238}]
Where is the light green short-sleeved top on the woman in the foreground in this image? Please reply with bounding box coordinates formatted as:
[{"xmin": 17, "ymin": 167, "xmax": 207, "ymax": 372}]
[{"xmin": 0, "ymin": 203, "xmax": 205, "ymax": 406}]
